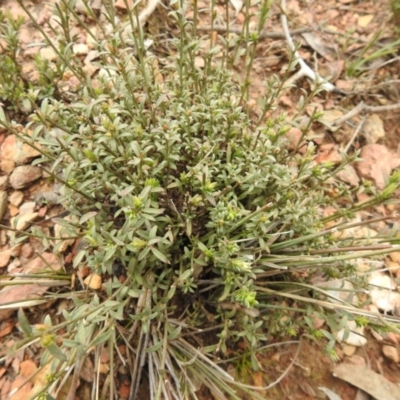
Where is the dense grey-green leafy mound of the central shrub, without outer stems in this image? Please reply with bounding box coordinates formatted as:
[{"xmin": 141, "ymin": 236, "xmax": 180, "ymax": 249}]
[{"xmin": 35, "ymin": 38, "xmax": 334, "ymax": 305}]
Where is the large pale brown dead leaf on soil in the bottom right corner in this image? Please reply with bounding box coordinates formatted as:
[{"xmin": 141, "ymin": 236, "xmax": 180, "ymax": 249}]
[{"xmin": 333, "ymin": 364, "xmax": 400, "ymax": 400}]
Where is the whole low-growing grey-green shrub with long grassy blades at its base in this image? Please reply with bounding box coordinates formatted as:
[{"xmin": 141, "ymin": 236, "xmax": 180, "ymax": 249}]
[{"xmin": 1, "ymin": 1, "xmax": 399, "ymax": 399}]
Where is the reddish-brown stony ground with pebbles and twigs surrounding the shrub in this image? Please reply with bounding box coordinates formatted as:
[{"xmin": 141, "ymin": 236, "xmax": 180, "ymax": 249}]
[{"xmin": 0, "ymin": 0, "xmax": 400, "ymax": 400}]
